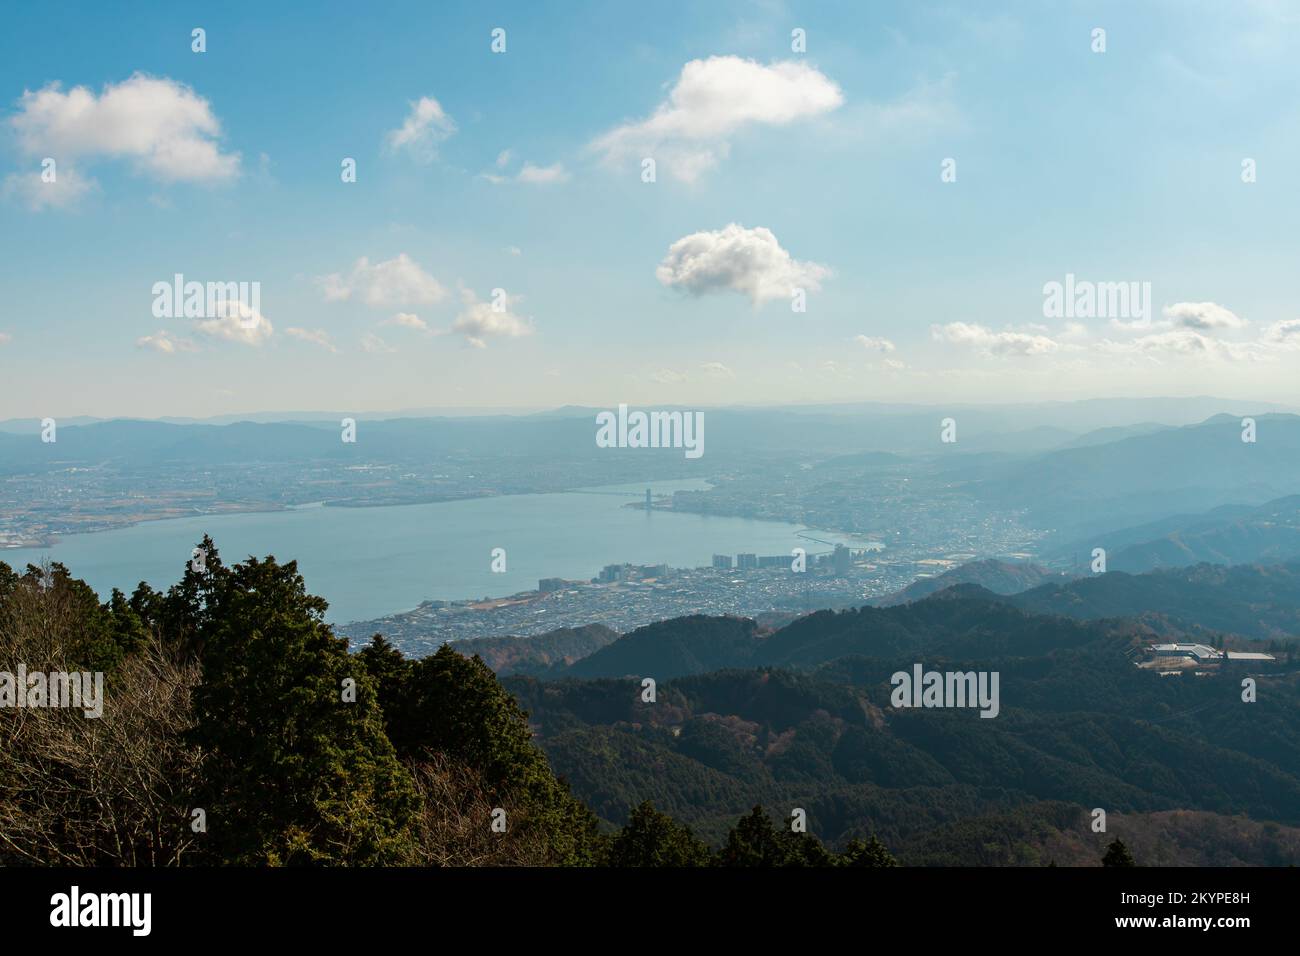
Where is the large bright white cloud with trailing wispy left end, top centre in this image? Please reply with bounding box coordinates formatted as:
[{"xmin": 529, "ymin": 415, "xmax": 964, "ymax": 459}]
[{"xmin": 592, "ymin": 56, "xmax": 844, "ymax": 182}]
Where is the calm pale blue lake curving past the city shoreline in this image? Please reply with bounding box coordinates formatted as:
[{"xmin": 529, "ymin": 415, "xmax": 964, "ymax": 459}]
[{"xmin": 0, "ymin": 481, "xmax": 857, "ymax": 623}]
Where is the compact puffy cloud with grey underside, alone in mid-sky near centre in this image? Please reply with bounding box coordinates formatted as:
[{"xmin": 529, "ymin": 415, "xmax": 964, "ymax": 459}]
[{"xmin": 655, "ymin": 222, "xmax": 831, "ymax": 306}]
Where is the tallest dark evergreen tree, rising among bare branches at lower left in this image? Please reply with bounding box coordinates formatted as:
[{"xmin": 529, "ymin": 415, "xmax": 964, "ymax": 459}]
[{"xmin": 183, "ymin": 538, "xmax": 416, "ymax": 864}]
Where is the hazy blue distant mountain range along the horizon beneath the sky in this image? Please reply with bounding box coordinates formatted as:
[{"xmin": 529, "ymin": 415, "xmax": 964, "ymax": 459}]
[{"xmin": 0, "ymin": 398, "xmax": 1294, "ymax": 460}]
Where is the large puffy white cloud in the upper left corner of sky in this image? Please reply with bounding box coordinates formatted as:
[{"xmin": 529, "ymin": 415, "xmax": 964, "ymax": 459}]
[{"xmin": 9, "ymin": 73, "xmax": 239, "ymax": 182}]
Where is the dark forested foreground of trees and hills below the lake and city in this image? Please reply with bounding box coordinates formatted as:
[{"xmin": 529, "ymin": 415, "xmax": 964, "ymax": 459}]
[{"xmin": 0, "ymin": 540, "xmax": 1300, "ymax": 866}]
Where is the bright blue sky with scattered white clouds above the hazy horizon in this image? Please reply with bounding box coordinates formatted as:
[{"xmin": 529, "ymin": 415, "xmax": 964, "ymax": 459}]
[{"xmin": 0, "ymin": 1, "xmax": 1300, "ymax": 418}]
